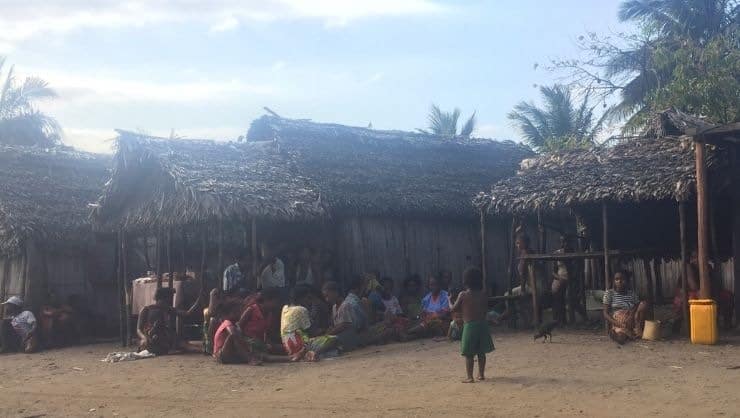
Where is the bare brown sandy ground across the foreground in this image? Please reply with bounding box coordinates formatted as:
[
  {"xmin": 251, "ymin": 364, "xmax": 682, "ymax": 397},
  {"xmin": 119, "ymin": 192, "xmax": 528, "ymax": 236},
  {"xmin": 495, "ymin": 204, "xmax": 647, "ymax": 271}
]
[{"xmin": 0, "ymin": 331, "xmax": 740, "ymax": 417}]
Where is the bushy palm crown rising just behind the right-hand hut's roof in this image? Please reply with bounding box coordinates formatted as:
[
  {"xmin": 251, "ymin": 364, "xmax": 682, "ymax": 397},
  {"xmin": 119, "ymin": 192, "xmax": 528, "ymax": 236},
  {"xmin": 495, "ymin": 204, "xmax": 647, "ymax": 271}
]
[{"xmin": 508, "ymin": 84, "xmax": 605, "ymax": 151}]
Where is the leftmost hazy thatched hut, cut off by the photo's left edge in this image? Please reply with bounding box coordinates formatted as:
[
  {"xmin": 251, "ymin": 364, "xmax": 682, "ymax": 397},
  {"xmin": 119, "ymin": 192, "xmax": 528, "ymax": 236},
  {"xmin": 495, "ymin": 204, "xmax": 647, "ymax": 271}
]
[{"xmin": 0, "ymin": 145, "xmax": 117, "ymax": 328}]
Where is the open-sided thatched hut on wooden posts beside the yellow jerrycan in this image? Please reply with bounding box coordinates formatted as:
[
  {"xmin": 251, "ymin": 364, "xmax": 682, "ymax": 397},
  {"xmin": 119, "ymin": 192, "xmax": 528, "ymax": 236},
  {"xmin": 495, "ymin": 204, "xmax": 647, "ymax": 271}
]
[{"xmin": 474, "ymin": 110, "xmax": 740, "ymax": 330}]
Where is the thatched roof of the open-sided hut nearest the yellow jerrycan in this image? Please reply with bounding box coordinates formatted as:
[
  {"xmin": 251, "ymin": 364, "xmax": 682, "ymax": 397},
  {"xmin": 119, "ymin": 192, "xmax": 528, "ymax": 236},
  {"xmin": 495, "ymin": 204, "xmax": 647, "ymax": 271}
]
[{"xmin": 474, "ymin": 110, "xmax": 715, "ymax": 213}]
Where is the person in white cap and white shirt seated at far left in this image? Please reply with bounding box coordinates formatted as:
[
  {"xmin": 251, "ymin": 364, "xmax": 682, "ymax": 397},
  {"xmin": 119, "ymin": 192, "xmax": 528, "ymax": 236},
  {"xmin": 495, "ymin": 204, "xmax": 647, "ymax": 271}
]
[{"xmin": 0, "ymin": 296, "xmax": 39, "ymax": 353}]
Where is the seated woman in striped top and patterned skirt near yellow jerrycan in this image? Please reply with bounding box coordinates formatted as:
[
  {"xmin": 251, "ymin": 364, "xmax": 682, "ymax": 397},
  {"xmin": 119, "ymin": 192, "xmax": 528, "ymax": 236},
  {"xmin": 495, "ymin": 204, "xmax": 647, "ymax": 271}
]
[{"xmin": 603, "ymin": 272, "xmax": 648, "ymax": 344}]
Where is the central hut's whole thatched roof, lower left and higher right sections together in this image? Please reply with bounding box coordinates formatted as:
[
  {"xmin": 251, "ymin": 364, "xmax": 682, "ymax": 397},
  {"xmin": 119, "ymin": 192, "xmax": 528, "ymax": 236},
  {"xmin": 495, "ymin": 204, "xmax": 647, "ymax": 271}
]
[{"xmin": 98, "ymin": 116, "xmax": 532, "ymax": 226}]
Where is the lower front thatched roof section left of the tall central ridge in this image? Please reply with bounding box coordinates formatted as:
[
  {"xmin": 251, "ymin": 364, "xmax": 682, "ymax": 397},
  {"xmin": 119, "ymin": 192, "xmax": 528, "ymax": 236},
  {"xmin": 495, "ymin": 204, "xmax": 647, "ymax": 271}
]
[{"xmin": 92, "ymin": 131, "xmax": 324, "ymax": 226}]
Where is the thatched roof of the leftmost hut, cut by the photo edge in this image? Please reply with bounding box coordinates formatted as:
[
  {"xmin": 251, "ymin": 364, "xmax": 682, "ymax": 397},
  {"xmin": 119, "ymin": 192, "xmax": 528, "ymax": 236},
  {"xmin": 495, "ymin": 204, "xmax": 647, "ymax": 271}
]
[{"xmin": 0, "ymin": 145, "xmax": 108, "ymax": 253}]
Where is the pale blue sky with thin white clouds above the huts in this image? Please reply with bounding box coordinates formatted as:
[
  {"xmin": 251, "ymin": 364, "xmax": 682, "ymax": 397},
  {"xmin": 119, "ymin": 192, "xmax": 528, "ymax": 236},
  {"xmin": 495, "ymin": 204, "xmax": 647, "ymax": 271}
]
[{"xmin": 0, "ymin": 0, "xmax": 624, "ymax": 152}]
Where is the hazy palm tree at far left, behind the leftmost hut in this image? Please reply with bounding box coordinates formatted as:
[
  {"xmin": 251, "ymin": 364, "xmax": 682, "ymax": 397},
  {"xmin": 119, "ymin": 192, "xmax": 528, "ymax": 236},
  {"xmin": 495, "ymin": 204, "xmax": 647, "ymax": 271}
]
[{"xmin": 0, "ymin": 57, "xmax": 61, "ymax": 146}]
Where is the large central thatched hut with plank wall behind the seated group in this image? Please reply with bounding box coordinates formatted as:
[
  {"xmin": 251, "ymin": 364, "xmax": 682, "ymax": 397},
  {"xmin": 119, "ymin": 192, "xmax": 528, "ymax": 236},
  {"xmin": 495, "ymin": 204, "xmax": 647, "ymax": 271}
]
[{"xmin": 98, "ymin": 116, "xmax": 531, "ymax": 298}]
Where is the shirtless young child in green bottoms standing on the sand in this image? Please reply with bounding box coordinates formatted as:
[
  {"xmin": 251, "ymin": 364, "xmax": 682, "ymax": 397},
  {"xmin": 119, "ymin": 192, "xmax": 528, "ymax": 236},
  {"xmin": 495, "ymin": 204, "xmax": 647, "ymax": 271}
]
[{"xmin": 450, "ymin": 267, "xmax": 494, "ymax": 383}]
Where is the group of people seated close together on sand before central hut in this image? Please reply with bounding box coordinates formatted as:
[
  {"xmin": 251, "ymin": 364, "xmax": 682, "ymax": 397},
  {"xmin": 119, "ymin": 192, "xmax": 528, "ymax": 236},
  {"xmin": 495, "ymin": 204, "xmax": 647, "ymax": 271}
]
[{"xmin": 204, "ymin": 274, "xmax": 468, "ymax": 364}]
